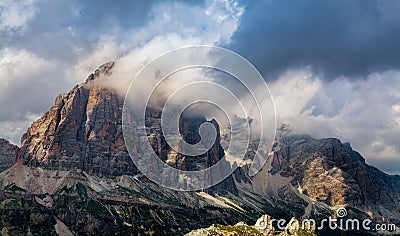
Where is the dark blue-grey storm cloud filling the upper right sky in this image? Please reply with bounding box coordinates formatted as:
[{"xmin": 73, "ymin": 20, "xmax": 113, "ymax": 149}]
[{"xmin": 233, "ymin": 0, "xmax": 400, "ymax": 78}]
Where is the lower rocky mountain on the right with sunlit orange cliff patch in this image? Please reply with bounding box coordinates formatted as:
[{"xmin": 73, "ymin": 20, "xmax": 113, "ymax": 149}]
[{"xmin": 235, "ymin": 135, "xmax": 400, "ymax": 227}]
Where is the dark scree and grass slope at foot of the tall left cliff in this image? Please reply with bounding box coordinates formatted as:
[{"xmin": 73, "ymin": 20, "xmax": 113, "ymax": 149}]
[{"xmin": 0, "ymin": 163, "xmax": 248, "ymax": 235}]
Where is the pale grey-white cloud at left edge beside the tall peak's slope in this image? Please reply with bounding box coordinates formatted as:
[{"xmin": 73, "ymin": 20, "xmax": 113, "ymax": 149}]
[{"xmin": 0, "ymin": 48, "xmax": 72, "ymax": 143}]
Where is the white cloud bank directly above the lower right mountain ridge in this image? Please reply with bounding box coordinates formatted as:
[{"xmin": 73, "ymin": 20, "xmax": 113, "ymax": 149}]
[{"xmin": 270, "ymin": 68, "xmax": 400, "ymax": 173}]
